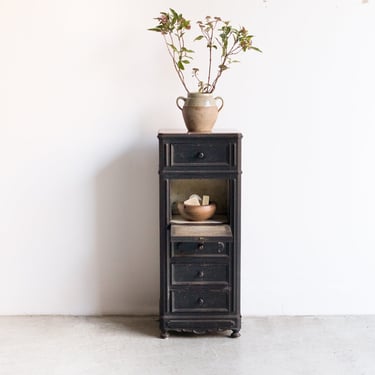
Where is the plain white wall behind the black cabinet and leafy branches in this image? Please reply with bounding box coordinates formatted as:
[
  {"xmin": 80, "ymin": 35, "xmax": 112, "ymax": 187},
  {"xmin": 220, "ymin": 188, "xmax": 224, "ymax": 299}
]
[{"xmin": 0, "ymin": 0, "xmax": 375, "ymax": 315}]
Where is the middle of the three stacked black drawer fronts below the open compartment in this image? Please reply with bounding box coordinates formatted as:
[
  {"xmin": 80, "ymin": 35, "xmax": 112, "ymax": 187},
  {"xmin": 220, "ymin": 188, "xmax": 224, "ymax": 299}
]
[{"xmin": 171, "ymin": 263, "xmax": 229, "ymax": 285}]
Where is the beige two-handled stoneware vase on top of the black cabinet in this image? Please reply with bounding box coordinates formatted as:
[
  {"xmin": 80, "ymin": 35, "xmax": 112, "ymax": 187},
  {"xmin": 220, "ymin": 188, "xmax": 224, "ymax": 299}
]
[{"xmin": 176, "ymin": 92, "xmax": 224, "ymax": 133}]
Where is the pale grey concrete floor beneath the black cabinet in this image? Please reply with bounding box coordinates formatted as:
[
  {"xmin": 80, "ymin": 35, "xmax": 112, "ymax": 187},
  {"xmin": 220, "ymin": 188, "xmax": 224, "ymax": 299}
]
[{"xmin": 0, "ymin": 316, "xmax": 375, "ymax": 375}]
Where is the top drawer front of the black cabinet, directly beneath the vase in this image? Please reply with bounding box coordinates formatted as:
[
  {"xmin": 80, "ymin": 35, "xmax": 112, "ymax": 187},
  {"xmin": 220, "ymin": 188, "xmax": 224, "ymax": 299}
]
[{"xmin": 170, "ymin": 141, "xmax": 234, "ymax": 167}]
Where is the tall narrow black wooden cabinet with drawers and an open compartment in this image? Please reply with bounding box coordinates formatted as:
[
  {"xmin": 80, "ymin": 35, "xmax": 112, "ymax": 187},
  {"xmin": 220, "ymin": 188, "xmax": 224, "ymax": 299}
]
[{"xmin": 158, "ymin": 131, "xmax": 242, "ymax": 338}]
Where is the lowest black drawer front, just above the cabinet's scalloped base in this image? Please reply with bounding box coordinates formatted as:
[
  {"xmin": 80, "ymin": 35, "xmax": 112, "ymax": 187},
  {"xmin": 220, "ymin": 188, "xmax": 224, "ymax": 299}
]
[{"xmin": 171, "ymin": 288, "xmax": 230, "ymax": 312}]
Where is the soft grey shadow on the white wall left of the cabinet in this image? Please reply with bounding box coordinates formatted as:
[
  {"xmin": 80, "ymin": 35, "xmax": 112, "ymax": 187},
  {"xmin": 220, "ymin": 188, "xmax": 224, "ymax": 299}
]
[{"xmin": 96, "ymin": 137, "xmax": 159, "ymax": 315}]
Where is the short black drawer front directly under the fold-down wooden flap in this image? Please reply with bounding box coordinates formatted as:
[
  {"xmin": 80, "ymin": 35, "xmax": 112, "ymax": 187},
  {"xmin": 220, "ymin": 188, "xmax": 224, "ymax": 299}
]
[{"xmin": 172, "ymin": 241, "xmax": 229, "ymax": 257}]
